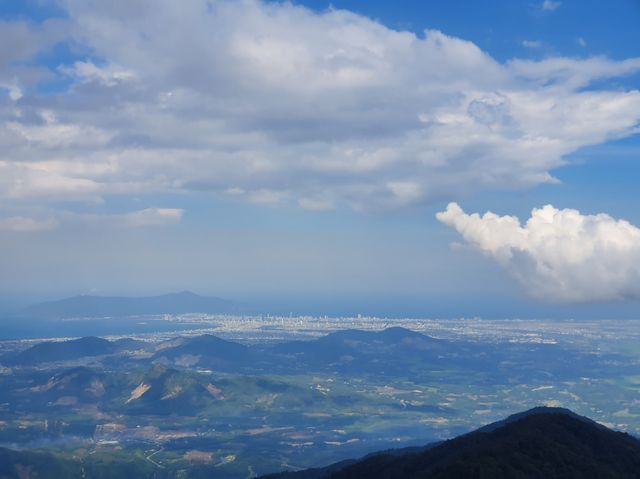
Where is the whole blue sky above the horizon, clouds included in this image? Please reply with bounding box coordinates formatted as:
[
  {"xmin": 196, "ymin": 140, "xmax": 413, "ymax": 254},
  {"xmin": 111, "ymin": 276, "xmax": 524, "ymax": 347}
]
[{"xmin": 0, "ymin": 0, "xmax": 640, "ymax": 318}]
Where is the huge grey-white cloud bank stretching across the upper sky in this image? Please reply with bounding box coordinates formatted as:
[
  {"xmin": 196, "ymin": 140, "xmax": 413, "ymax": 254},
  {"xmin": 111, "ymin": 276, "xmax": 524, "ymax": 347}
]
[{"xmin": 0, "ymin": 0, "xmax": 640, "ymax": 214}]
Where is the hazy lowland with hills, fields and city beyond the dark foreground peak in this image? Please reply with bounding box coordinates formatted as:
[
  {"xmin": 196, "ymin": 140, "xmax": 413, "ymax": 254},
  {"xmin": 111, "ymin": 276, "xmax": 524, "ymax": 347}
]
[{"xmin": 0, "ymin": 313, "xmax": 640, "ymax": 478}]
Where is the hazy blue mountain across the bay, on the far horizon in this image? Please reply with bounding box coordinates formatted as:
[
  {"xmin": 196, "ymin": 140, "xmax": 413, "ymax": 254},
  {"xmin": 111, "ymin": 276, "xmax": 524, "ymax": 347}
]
[{"xmin": 23, "ymin": 291, "xmax": 256, "ymax": 318}]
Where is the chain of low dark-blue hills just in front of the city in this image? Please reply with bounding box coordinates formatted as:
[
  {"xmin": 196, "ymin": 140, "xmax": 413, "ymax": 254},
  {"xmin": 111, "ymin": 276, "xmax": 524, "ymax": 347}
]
[{"xmin": 0, "ymin": 327, "xmax": 470, "ymax": 375}]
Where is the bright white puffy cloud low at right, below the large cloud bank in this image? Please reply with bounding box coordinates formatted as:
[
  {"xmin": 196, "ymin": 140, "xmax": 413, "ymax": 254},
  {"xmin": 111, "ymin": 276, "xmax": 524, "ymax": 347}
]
[{"xmin": 437, "ymin": 203, "xmax": 640, "ymax": 302}]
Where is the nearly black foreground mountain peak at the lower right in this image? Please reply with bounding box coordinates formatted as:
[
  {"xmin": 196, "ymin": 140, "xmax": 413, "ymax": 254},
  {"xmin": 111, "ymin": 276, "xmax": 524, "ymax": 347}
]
[{"xmin": 265, "ymin": 407, "xmax": 640, "ymax": 479}]
